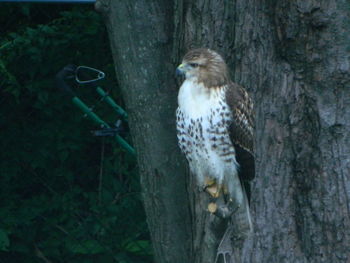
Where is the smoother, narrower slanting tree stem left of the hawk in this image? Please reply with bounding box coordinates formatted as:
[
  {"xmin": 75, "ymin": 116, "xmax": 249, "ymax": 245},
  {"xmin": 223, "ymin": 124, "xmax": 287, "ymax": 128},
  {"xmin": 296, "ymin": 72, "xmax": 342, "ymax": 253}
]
[{"xmin": 95, "ymin": 0, "xmax": 191, "ymax": 263}]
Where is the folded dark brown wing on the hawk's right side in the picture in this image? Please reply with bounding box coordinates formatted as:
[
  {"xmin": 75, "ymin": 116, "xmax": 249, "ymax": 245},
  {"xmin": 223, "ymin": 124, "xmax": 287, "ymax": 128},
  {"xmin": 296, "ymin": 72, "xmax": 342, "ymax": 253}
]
[{"xmin": 226, "ymin": 82, "xmax": 255, "ymax": 184}]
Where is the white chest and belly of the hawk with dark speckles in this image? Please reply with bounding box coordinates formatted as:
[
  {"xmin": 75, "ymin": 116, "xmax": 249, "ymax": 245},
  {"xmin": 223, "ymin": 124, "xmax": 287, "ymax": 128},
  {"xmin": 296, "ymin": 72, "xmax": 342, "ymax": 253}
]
[{"xmin": 176, "ymin": 83, "xmax": 236, "ymax": 183}]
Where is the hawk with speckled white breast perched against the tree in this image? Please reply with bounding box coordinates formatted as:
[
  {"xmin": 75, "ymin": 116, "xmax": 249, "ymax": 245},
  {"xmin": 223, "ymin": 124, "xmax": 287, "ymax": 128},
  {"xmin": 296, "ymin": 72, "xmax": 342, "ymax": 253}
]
[{"xmin": 176, "ymin": 48, "xmax": 255, "ymax": 262}]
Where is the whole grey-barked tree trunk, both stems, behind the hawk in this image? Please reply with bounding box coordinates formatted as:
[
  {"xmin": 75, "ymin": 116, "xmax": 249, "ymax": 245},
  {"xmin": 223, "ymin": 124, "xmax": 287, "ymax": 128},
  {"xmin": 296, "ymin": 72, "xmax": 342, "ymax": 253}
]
[{"xmin": 96, "ymin": 0, "xmax": 350, "ymax": 263}]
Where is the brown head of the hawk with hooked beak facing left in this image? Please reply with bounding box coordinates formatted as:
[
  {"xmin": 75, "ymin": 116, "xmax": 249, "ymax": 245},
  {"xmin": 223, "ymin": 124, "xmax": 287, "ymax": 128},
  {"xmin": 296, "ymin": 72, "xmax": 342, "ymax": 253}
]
[{"xmin": 176, "ymin": 48, "xmax": 229, "ymax": 88}]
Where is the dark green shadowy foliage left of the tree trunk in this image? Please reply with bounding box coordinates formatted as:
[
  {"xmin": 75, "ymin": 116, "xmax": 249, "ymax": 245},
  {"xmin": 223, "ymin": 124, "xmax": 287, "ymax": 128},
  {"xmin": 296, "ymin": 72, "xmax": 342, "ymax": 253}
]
[{"xmin": 0, "ymin": 4, "xmax": 151, "ymax": 263}]
